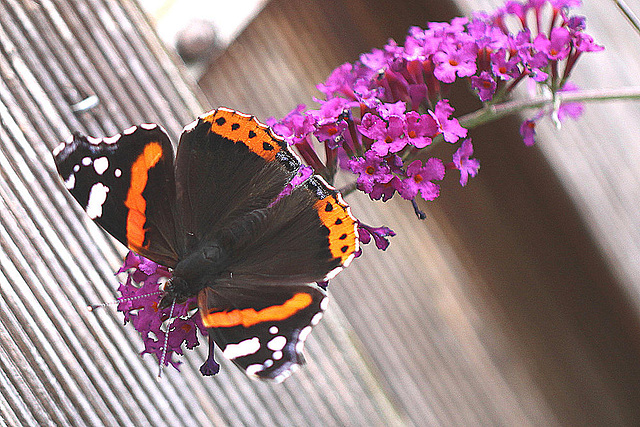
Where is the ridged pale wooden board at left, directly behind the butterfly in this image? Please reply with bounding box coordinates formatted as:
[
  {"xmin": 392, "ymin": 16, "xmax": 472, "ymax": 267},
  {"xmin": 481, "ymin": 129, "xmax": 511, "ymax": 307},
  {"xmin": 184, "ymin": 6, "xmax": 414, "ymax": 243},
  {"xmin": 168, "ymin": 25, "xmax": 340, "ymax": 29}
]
[{"xmin": 0, "ymin": 0, "xmax": 400, "ymax": 426}]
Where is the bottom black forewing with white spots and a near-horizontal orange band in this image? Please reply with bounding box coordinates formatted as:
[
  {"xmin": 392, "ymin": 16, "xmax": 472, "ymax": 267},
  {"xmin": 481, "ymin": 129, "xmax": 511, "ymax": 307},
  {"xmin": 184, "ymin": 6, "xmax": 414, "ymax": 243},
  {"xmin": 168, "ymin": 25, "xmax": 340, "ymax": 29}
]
[{"xmin": 198, "ymin": 281, "xmax": 328, "ymax": 382}]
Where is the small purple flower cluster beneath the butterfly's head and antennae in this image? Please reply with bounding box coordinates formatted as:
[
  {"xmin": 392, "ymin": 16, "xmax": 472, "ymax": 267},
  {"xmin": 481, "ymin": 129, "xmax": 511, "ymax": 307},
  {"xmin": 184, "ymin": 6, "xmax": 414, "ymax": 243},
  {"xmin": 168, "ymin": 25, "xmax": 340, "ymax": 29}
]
[{"xmin": 117, "ymin": 252, "xmax": 219, "ymax": 375}]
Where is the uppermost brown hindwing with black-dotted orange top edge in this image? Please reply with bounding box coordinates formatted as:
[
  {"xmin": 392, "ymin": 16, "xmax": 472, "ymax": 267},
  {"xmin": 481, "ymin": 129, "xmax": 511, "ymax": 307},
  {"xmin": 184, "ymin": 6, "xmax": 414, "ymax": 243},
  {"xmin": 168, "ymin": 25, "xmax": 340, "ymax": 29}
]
[{"xmin": 176, "ymin": 108, "xmax": 300, "ymax": 248}]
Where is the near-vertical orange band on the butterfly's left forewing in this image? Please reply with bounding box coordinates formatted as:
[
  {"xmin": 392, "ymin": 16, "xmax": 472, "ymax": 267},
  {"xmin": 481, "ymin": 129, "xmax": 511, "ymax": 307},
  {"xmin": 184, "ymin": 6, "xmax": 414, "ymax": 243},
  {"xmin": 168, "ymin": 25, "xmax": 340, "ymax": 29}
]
[{"xmin": 124, "ymin": 142, "xmax": 162, "ymax": 251}]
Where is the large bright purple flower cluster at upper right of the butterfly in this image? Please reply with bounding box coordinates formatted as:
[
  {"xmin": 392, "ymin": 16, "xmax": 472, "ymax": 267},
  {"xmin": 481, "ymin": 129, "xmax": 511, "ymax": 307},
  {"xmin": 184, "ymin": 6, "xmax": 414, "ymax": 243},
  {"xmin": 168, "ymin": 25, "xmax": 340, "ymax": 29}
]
[{"xmin": 268, "ymin": 0, "xmax": 602, "ymax": 216}]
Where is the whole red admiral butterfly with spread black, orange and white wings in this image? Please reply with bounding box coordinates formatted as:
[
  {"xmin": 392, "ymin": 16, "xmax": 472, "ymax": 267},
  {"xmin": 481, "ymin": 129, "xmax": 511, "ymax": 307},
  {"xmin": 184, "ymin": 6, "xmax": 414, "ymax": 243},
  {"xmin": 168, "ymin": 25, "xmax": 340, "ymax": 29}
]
[{"xmin": 53, "ymin": 108, "xmax": 358, "ymax": 380}]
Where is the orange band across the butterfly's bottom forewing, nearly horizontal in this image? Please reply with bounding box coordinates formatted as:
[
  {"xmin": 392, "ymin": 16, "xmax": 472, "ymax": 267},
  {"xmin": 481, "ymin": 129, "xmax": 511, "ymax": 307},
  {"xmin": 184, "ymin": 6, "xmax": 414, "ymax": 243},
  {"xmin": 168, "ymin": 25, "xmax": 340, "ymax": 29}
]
[{"xmin": 202, "ymin": 292, "xmax": 313, "ymax": 328}]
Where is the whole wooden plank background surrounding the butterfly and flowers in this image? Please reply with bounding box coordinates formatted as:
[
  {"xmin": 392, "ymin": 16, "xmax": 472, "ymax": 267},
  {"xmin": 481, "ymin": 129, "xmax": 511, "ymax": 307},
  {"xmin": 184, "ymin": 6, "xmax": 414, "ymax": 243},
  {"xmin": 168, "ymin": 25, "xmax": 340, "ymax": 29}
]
[{"xmin": 0, "ymin": 0, "xmax": 640, "ymax": 426}]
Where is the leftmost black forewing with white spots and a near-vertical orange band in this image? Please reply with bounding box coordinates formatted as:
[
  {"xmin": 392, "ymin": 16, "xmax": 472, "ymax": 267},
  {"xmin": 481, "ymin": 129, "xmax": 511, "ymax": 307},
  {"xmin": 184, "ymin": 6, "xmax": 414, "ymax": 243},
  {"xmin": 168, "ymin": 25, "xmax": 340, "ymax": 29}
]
[{"xmin": 54, "ymin": 125, "xmax": 178, "ymax": 267}]
